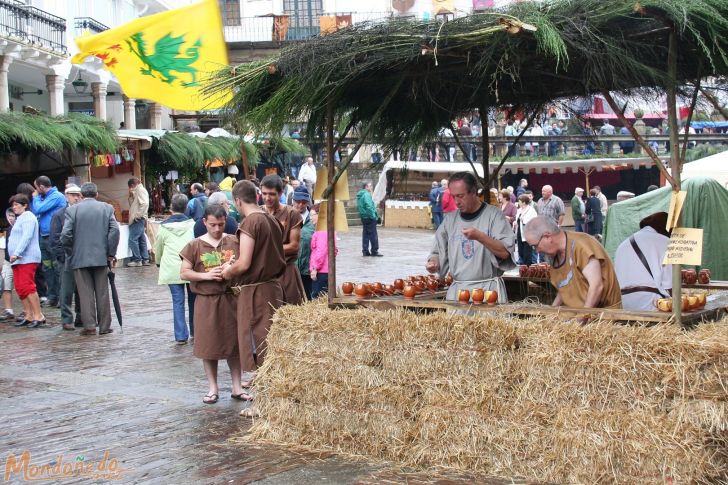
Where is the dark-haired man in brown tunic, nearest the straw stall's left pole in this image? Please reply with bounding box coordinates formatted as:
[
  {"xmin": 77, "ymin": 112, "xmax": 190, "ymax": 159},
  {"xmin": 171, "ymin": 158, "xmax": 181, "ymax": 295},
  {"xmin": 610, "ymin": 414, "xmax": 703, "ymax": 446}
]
[{"xmin": 260, "ymin": 175, "xmax": 306, "ymax": 305}]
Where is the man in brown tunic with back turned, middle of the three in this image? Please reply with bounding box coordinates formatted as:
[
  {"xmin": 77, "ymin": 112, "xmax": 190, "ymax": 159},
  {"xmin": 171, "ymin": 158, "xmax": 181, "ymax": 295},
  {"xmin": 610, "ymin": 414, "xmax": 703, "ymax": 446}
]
[{"xmin": 222, "ymin": 180, "xmax": 286, "ymax": 415}]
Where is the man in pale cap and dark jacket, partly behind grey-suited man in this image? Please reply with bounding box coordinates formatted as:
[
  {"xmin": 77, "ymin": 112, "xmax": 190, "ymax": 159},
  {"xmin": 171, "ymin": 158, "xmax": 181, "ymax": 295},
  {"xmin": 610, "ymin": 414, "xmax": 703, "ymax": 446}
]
[{"xmin": 49, "ymin": 184, "xmax": 82, "ymax": 330}]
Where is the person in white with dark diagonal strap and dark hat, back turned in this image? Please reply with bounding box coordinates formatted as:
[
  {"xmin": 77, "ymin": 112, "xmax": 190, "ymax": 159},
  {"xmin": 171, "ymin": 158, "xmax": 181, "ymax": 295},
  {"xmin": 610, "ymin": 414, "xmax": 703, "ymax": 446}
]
[{"xmin": 614, "ymin": 212, "xmax": 672, "ymax": 310}]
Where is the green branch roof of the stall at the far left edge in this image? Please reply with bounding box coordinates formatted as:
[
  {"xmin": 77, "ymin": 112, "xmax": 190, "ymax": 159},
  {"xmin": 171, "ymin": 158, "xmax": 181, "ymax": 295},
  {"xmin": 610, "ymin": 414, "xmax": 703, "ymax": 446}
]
[{"xmin": 0, "ymin": 112, "xmax": 119, "ymax": 153}]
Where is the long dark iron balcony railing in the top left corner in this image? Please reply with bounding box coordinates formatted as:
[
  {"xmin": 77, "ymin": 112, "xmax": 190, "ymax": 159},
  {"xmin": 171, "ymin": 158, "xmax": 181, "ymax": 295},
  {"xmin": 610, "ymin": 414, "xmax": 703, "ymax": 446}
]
[{"xmin": 0, "ymin": 0, "xmax": 68, "ymax": 53}]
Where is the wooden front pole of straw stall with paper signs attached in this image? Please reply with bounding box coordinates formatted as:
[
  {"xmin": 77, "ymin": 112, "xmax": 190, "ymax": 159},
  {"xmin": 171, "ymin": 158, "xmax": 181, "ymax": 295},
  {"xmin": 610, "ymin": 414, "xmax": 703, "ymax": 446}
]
[{"xmin": 667, "ymin": 27, "xmax": 682, "ymax": 325}]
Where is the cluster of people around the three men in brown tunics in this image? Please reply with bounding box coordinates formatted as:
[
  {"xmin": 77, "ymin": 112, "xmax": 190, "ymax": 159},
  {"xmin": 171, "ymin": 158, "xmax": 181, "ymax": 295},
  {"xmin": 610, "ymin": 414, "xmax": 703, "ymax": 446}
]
[{"xmin": 154, "ymin": 170, "xmax": 336, "ymax": 416}]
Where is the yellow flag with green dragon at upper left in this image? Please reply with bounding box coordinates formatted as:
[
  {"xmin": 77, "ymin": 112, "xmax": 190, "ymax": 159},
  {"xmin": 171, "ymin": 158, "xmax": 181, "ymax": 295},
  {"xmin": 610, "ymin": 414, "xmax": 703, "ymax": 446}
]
[{"xmin": 72, "ymin": 0, "xmax": 231, "ymax": 110}]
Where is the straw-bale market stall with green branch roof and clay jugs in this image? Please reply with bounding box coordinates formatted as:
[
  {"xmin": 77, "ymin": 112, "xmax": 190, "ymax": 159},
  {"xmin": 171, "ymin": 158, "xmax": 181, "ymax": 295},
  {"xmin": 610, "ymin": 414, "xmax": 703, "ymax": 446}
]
[{"xmin": 205, "ymin": 0, "xmax": 728, "ymax": 483}]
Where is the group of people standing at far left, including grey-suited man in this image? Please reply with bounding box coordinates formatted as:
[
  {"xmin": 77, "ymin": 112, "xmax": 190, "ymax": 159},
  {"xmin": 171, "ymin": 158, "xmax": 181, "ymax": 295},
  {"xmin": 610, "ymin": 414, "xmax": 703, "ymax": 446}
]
[{"xmin": 1, "ymin": 175, "xmax": 119, "ymax": 335}]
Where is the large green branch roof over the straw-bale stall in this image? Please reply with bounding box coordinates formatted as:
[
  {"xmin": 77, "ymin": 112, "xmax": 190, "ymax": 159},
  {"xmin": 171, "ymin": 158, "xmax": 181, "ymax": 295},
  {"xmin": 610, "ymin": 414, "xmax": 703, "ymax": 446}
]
[{"xmin": 207, "ymin": 0, "xmax": 728, "ymax": 150}]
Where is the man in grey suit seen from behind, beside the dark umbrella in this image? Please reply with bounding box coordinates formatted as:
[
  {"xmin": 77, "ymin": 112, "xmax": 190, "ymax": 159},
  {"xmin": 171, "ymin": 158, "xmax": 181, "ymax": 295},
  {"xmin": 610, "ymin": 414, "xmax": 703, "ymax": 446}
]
[{"xmin": 61, "ymin": 183, "xmax": 119, "ymax": 335}]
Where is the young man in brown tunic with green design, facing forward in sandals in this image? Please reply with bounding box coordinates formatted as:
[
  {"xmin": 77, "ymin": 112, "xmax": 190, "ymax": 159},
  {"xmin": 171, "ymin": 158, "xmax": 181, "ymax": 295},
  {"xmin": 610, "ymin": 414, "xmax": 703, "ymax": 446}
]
[{"xmin": 179, "ymin": 205, "xmax": 245, "ymax": 404}]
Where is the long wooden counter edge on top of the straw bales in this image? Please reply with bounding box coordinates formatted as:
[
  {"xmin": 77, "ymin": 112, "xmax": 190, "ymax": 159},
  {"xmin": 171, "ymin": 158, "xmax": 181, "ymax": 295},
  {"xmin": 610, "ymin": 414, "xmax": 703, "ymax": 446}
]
[{"xmin": 333, "ymin": 292, "xmax": 728, "ymax": 325}]
